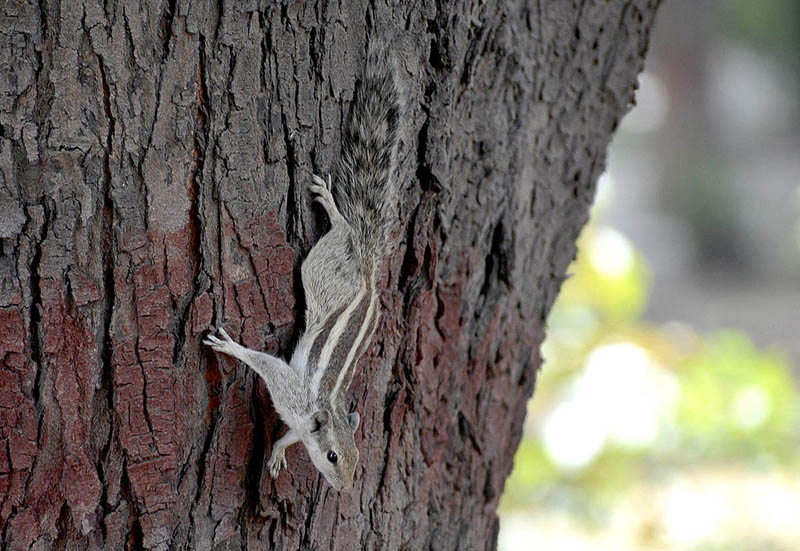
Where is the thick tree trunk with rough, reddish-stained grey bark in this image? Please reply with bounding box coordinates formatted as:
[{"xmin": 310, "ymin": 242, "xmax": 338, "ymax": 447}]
[{"xmin": 0, "ymin": 0, "xmax": 658, "ymax": 550}]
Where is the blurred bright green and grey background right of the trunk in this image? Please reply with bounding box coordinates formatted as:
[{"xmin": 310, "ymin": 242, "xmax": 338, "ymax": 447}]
[{"xmin": 499, "ymin": 0, "xmax": 800, "ymax": 551}]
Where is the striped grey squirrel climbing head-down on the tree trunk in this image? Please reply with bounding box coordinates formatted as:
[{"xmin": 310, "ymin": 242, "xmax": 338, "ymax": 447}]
[{"xmin": 203, "ymin": 39, "xmax": 401, "ymax": 492}]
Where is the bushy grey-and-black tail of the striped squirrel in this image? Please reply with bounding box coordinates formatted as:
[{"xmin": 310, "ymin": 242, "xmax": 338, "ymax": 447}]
[{"xmin": 334, "ymin": 38, "xmax": 402, "ymax": 264}]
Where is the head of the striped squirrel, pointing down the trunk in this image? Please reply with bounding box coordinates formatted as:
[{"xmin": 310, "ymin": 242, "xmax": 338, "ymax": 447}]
[{"xmin": 306, "ymin": 409, "xmax": 361, "ymax": 492}]
